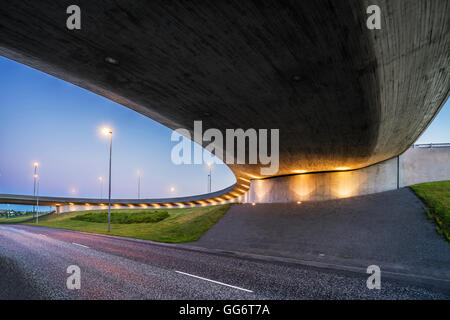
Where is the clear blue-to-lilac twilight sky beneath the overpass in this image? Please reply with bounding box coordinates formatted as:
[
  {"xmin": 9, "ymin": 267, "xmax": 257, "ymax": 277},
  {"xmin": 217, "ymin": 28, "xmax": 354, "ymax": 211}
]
[{"xmin": 0, "ymin": 57, "xmax": 450, "ymax": 207}]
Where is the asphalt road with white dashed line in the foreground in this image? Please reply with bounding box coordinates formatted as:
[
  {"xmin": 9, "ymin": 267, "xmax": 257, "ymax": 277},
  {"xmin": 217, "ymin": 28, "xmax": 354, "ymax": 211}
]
[{"xmin": 0, "ymin": 225, "xmax": 450, "ymax": 300}]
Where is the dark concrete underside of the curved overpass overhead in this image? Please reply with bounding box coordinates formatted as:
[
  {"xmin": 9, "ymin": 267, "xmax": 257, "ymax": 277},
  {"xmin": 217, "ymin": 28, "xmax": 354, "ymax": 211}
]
[{"xmin": 0, "ymin": 0, "xmax": 450, "ymax": 198}]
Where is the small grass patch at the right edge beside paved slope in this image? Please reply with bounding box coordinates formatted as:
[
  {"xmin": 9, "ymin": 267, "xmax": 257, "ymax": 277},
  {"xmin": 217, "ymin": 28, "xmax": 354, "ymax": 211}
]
[{"xmin": 410, "ymin": 181, "xmax": 450, "ymax": 241}]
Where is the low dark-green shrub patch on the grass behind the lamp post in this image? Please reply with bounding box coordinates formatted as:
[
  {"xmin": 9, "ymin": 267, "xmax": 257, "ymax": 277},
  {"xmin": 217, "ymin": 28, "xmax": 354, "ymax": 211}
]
[{"xmin": 71, "ymin": 210, "xmax": 169, "ymax": 224}]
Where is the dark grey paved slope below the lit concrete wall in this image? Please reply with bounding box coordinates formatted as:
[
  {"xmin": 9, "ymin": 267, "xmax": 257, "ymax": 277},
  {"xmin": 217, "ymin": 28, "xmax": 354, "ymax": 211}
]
[{"xmin": 195, "ymin": 188, "xmax": 450, "ymax": 279}]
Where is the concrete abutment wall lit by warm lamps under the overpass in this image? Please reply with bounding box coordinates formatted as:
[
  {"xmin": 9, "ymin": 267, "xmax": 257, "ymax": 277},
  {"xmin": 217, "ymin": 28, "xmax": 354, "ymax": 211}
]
[{"xmin": 248, "ymin": 147, "xmax": 450, "ymax": 203}]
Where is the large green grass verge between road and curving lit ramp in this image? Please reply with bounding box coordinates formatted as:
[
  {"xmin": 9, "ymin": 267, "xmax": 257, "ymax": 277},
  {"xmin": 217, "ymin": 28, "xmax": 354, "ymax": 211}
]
[{"xmin": 22, "ymin": 204, "xmax": 230, "ymax": 243}]
